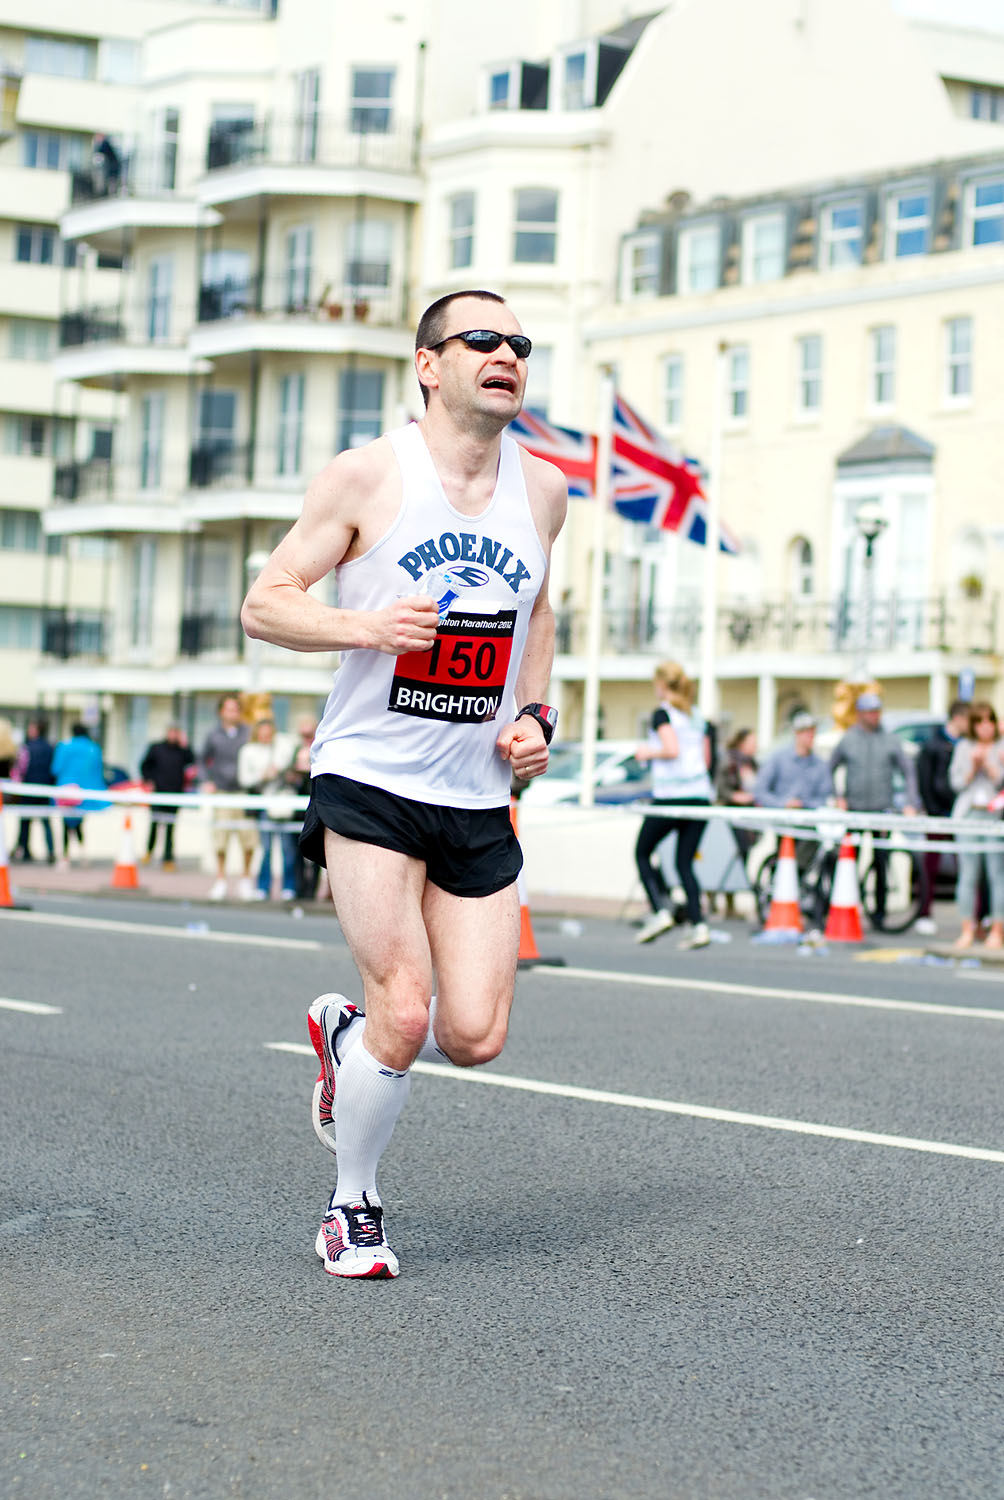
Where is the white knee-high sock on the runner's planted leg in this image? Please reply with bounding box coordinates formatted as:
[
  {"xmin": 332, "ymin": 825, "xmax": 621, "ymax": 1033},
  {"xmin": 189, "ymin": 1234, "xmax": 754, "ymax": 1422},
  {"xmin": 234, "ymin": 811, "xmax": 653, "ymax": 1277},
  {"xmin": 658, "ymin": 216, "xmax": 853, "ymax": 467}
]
[{"xmin": 332, "ymin": 1028, "xmax": 411, "ymax": 1205}]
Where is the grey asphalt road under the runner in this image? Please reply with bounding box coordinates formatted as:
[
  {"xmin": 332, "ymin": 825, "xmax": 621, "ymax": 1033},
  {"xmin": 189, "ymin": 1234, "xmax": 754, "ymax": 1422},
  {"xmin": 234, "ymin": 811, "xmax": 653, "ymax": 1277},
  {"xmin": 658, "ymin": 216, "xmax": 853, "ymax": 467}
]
[{"xmin": 0, "ymin": 899, "xmax": 1004, "ymax": 1500}]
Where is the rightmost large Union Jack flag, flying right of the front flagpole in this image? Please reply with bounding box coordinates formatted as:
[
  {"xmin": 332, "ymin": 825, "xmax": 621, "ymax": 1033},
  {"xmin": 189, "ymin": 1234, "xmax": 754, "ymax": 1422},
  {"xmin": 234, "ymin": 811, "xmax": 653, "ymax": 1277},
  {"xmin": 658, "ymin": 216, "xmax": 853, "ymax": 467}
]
[{"xmin": 611, "ymin": 396, "xmax": 740, "ymax": 555}]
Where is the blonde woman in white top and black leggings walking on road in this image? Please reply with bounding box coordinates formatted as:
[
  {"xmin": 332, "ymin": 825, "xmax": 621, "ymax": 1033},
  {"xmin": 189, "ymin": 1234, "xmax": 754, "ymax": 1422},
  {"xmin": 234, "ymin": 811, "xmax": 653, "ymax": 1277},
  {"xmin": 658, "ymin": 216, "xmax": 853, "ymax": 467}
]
[{"xmin": 635, "ymin": 662, "xmax": 711, "ymax": 948}]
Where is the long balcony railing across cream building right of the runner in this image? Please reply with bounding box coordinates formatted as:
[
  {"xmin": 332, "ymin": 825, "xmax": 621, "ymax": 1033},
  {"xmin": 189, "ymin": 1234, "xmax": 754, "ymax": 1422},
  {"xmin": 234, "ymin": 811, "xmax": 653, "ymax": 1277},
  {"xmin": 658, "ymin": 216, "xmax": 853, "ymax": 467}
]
[{"xmin": 557, "ymin": 594, "xmax": 1004, "ymax": 663}]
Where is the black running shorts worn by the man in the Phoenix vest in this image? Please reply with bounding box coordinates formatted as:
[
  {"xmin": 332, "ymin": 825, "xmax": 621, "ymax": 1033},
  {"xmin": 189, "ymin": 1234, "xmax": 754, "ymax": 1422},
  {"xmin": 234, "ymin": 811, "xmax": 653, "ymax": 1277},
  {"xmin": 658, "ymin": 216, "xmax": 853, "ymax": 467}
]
[{"xmin": 300, "ymin": 776, "xmax": 522, "ymax": 896}]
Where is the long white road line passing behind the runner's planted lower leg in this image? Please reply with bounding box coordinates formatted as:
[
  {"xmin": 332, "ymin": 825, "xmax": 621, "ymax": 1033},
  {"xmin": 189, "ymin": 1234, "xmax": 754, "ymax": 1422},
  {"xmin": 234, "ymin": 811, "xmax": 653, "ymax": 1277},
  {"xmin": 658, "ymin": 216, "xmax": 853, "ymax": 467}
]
[{"xmin": 266, "ymin": 1041, "xmax": 1004, "ymax": 1163}]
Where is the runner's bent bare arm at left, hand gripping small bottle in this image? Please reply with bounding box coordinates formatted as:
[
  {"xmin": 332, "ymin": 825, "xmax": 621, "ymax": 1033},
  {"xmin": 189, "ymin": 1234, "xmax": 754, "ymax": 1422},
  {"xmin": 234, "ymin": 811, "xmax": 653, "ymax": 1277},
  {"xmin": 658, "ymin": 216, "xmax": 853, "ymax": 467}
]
[{"xmin": 240, "ymin": 449, "xmax": 438, "ymax": 656}]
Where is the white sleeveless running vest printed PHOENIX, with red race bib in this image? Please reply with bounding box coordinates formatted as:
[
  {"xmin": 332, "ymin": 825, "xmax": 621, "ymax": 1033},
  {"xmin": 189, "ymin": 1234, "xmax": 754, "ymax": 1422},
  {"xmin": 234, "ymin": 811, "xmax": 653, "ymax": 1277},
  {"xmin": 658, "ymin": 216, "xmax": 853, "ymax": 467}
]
[{"xmin": 311, "ymin": 423, "xmax": 546, "ymax": 807}]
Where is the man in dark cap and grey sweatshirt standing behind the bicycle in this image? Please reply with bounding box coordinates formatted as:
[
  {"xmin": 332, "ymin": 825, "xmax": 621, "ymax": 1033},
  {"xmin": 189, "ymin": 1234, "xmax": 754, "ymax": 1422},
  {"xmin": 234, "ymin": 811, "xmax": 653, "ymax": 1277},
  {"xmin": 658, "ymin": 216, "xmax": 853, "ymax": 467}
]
[{"xmin": 830, "ymin": 693, "xmax": 917, "ymax": 927}]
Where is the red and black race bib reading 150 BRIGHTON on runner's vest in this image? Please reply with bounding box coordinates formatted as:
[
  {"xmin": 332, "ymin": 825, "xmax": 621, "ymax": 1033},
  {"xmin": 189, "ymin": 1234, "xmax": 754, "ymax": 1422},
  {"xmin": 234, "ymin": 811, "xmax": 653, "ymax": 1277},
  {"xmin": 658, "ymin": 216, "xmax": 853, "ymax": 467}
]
[{"xmin": 387, "ymin": 609, "xmax": 516, "ymax": 725}]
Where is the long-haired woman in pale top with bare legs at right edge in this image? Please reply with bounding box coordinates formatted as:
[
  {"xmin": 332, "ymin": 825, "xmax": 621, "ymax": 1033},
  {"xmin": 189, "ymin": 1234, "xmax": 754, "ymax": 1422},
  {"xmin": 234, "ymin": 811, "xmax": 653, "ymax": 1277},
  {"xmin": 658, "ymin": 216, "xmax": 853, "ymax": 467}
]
[{"xmin": 948, "ymin": 702, "xmax": 1004, "ymax": 948}]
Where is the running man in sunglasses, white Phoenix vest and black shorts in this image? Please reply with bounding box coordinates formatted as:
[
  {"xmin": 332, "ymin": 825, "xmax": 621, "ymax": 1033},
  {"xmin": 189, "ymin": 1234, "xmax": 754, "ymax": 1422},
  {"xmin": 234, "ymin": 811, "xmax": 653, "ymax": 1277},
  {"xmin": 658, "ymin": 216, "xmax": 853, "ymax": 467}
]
[{"xmin": 242, "ymin": 291, "xmax": 566, "ymax": 1278}]
